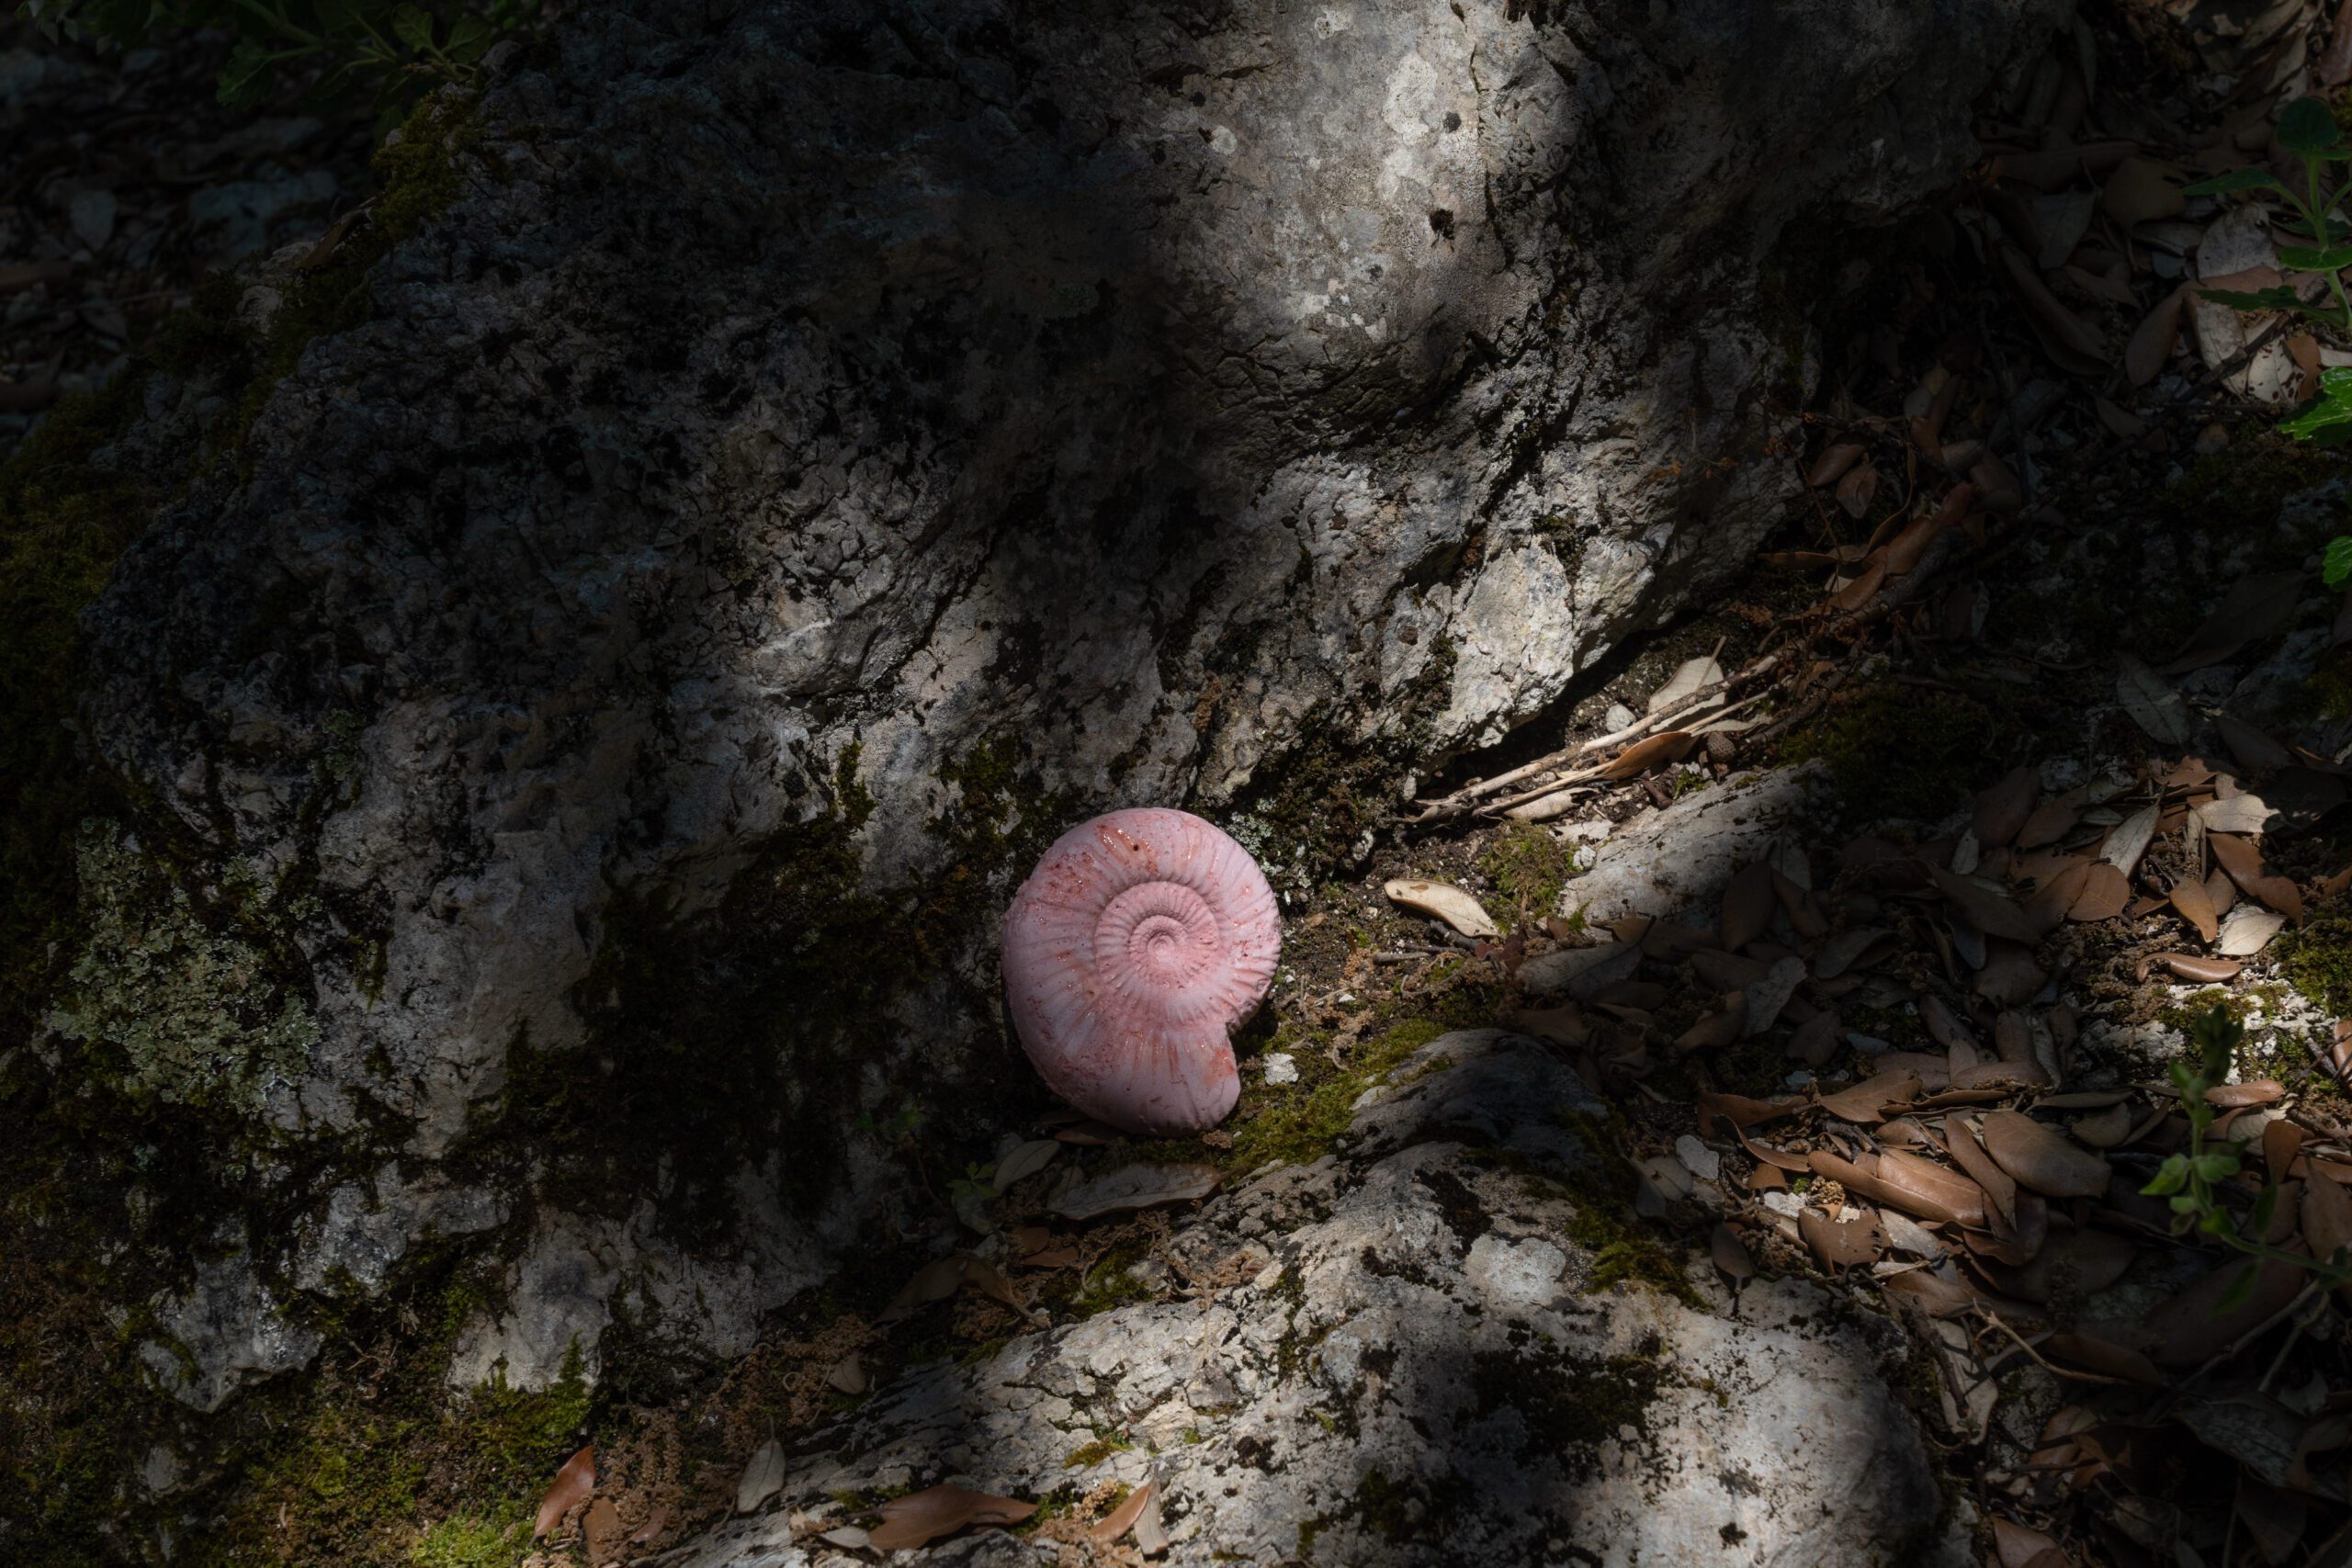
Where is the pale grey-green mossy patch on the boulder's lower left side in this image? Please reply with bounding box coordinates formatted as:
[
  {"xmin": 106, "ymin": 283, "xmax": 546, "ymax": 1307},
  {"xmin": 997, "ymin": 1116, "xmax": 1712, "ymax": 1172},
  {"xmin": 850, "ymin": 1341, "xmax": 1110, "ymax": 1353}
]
[{"xmin": 50, "ymin": 823, "xmax": 318, "ymax": 1114}]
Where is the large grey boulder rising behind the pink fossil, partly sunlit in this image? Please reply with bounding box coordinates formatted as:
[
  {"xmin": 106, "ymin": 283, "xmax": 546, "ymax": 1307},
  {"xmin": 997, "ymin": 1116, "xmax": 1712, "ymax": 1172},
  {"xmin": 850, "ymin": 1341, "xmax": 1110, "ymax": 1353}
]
[{"xmin": 83, "ymin": 0, "xmax": 2058, "ymax": 1401}]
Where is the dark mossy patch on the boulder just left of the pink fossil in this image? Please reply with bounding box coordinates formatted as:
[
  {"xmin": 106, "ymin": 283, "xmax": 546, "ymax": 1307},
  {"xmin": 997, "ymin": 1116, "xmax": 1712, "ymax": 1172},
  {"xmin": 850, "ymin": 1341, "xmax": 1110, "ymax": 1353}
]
[{"xmin": 489, "ymin": 736, "xmax": 1091, "ymax": 1248}]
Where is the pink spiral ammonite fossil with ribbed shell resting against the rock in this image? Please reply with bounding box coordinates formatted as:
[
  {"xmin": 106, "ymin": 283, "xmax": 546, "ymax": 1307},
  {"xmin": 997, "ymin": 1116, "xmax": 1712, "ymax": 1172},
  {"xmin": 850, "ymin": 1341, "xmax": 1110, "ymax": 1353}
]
[{"xmin": 1004, "ymin": 807, "xmax": 1282, "ymax": 1134}]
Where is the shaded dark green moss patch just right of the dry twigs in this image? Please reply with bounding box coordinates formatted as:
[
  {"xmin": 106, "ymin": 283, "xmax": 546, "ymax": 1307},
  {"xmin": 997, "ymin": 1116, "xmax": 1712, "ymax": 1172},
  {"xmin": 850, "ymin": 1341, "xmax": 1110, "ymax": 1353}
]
[{"xmin": 1788, "ymin": 684, "xmax": 2004, "ymax": 820}]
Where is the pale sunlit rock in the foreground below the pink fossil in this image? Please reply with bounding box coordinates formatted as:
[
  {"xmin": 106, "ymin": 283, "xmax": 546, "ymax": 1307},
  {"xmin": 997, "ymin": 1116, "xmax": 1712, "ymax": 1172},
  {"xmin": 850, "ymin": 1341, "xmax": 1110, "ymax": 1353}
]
[{"xmin": 663, "ymin": 1030, "xmax": 1971, "ymax": 1568}]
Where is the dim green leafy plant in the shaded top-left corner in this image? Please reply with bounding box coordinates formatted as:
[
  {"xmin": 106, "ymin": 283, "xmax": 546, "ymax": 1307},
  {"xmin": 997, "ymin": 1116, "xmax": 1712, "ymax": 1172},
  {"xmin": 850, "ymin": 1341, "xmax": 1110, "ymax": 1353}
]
[{"xmin": 17, "ymin": 0, "xmax": 546, "ymax": 125}]
